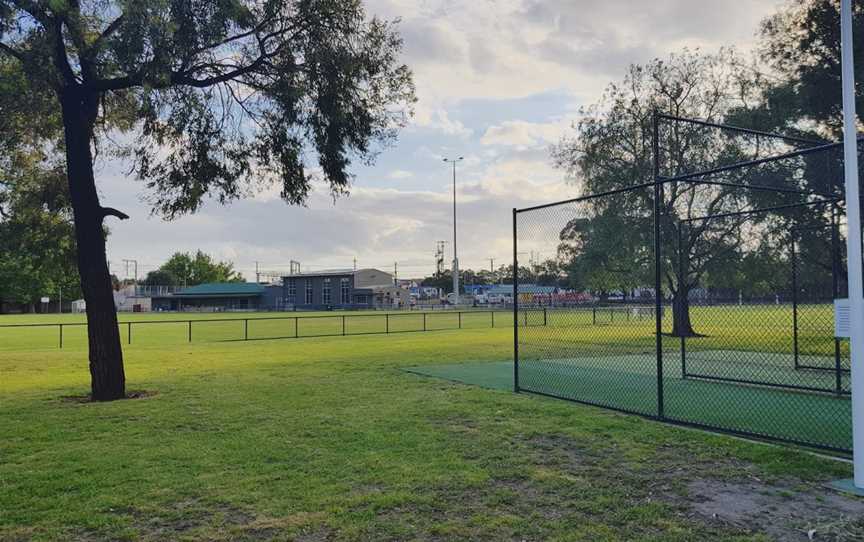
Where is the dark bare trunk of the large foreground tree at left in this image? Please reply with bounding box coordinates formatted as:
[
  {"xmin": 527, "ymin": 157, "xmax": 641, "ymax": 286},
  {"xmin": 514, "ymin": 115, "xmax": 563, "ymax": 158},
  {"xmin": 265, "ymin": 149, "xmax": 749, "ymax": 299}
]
[{"xmin": 60, "ymin": 86, "xmax": 126, "ymax": 401}]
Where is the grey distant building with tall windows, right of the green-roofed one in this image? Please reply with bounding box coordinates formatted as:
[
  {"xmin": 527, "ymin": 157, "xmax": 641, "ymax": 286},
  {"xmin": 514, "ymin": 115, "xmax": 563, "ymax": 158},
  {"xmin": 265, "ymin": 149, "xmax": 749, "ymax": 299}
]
[{"xmin": 282, "ymin": 268, "xmax": 410, "ymax": 310}]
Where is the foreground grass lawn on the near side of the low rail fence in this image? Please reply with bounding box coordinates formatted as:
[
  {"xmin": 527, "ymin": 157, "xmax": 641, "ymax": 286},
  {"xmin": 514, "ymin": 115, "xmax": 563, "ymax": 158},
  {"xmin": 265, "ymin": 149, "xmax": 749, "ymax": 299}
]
[{"xmin": 0, "ymin": 315, "xmax": 864, "ymax": 541}]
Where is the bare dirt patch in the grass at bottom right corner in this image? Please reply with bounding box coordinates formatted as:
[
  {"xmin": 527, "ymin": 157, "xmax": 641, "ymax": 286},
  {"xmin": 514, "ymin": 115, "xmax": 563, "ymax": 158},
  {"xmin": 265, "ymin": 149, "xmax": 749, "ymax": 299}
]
[{"xmin": 687, "ymin": 478, "xmax": 864, "ymax": 541}]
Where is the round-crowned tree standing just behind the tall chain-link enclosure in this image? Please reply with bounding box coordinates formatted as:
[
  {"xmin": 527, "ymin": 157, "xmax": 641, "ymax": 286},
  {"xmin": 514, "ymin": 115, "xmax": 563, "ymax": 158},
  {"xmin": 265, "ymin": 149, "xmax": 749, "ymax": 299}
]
[{"xmin": 553, "ymin": 50, "xmax": 782, "ymax": 336}]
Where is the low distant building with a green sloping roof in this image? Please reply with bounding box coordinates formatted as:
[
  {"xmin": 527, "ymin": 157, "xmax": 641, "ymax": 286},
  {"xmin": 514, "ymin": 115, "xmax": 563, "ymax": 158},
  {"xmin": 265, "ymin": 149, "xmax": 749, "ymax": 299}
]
[{"xmin": 151, "ymin": 282, "xmax": 268, "ymax": 312}]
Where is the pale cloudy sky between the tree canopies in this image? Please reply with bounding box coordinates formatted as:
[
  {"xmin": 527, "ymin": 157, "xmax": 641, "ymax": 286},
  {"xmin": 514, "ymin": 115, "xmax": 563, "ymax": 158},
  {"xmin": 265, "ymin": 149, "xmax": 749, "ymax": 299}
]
[{"xmin": 97, "ymin": 0, "xmax": 782, "ymax": 280}]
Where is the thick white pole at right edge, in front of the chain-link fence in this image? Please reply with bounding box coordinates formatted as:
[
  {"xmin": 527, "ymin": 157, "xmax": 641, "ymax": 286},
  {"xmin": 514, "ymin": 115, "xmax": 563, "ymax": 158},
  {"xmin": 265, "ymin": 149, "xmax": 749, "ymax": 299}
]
[{"xmin": 840, "ymin": 0, "xmax": 864, "ymax": 490}]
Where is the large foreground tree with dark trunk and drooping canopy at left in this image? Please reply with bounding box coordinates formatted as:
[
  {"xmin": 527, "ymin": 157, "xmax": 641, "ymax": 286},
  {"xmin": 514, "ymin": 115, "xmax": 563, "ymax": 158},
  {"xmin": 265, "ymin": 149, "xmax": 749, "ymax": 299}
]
[{"xmin": 0, "ymin": 0, "xmax": 414, "ymax": 400}]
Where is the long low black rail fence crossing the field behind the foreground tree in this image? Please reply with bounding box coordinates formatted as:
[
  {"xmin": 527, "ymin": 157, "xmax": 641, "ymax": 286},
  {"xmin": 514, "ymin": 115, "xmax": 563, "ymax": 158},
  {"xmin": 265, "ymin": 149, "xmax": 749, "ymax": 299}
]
[{"xmin": 0, "ymin": 309, "xmax": 547, "ymax": 350}]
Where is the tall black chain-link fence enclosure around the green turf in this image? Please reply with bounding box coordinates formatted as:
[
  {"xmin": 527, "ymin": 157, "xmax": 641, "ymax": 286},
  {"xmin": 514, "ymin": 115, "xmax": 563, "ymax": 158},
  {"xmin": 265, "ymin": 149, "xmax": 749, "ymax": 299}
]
[{"xmin": 513, "ymin": 115, "xmax": 852, "ymax": 452}]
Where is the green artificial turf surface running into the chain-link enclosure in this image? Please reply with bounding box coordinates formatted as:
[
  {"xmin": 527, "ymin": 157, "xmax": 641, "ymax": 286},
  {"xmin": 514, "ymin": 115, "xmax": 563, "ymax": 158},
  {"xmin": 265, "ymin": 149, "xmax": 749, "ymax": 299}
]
[{"xmin": 407, "ymin": 355, "xmax": 852, "ymax": 450}]
